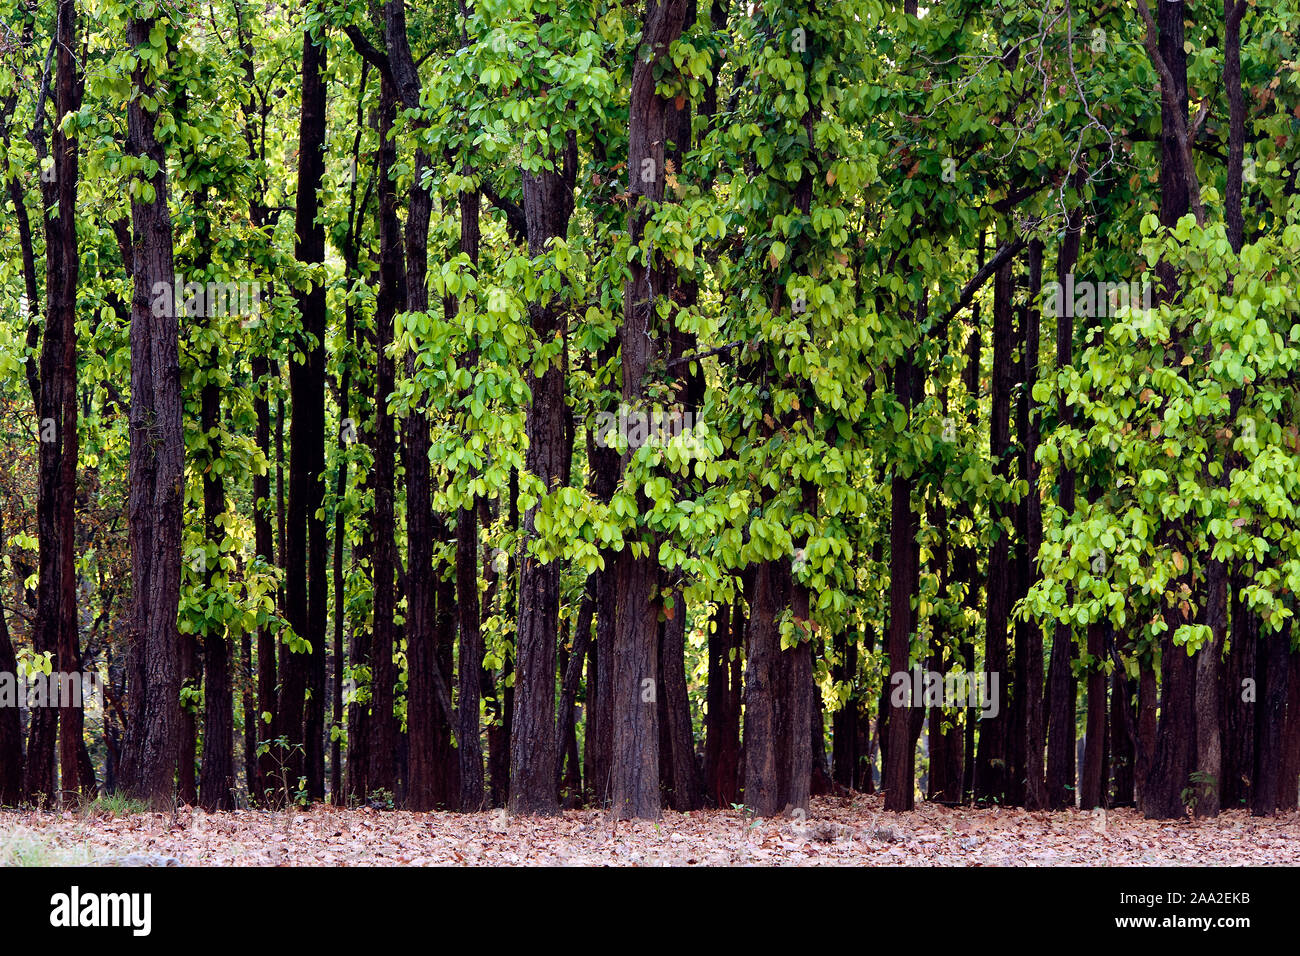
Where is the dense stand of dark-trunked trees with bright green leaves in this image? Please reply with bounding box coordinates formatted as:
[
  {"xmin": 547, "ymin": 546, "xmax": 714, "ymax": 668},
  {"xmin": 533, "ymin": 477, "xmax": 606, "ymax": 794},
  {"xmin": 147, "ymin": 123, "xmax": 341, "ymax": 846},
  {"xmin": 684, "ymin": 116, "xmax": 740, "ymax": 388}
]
[{"xmin": 0, "ymin": 0, "xmax": 1300, "ymax": 832}]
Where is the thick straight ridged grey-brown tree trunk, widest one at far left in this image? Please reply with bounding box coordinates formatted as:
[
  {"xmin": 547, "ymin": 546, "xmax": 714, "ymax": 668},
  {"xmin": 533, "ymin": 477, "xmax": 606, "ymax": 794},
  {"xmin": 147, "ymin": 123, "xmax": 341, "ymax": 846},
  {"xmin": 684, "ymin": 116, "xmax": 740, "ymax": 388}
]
[{"xmin": 122, "ymin": 18, "xmax": 185, "ymax": 808}]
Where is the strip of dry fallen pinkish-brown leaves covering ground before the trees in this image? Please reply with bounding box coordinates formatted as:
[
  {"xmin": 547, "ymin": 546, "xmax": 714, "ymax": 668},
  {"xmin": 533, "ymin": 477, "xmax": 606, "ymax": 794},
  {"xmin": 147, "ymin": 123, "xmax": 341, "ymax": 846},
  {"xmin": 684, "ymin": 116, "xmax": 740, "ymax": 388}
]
[{"xmin": 0, "ymin": 795, "xmax": 1300, "ymax": 866}]
